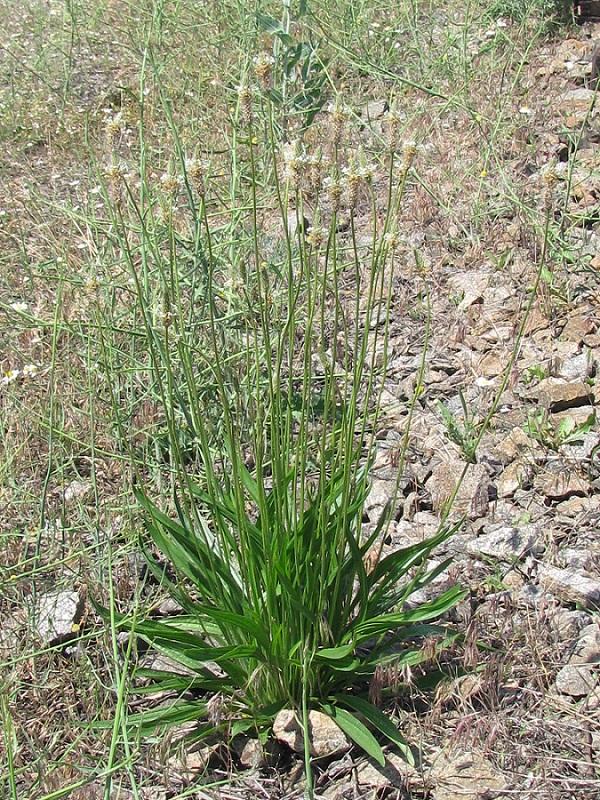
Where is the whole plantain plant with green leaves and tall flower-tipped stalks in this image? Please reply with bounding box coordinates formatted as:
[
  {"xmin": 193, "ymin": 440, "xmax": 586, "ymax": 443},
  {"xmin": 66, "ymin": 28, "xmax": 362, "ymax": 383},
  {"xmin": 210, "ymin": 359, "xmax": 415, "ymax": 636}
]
[{"xmin": 94, "ymin": 56, "xmax": 462, "ymax": 794}]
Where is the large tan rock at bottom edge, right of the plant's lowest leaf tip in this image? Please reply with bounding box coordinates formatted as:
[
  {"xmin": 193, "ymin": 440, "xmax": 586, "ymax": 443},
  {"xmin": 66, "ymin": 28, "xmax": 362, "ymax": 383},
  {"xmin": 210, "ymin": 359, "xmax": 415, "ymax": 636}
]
[{"xmin": 428, "ymin": 742, "xmax": 507, "ymax": 800}]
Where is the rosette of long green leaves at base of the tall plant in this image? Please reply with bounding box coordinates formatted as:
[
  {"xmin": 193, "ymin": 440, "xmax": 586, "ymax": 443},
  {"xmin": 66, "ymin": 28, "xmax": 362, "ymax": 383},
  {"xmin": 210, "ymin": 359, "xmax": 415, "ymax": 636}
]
[{"xmin": 111, "ymin": 465, "xmax": 463, "ymax": 763}]
